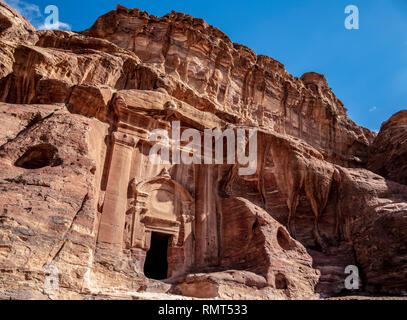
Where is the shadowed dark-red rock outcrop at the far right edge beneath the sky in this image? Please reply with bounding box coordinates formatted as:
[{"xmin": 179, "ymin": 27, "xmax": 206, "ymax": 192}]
[{"xmin": 368, "ymin": 110, "xmax": 407, "ymax": 185}]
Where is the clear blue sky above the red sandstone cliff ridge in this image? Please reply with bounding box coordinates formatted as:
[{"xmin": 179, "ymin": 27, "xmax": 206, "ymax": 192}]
[{"xmin": 6, "ymin": 0, "xmax": 407, "ymax": 131}]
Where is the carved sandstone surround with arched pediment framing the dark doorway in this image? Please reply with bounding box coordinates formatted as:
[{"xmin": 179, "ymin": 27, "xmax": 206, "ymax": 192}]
[{"xmin": 124, "ymin": 170, "xmax": 195, "ymax": 277}]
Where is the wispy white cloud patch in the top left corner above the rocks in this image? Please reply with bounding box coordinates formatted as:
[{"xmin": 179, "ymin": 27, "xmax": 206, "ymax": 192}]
[{"xmin": 3, "ymin": 0, "xmax": 72, "ymax": 30}]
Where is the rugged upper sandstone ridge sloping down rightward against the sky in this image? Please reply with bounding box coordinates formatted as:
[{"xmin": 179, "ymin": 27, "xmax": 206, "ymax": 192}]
[{"xmin": 83, "ymin": 6, "xmax": 374, "ymax": 166}]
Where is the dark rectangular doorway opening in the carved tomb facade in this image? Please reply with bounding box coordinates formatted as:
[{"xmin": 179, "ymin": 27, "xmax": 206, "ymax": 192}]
[{"xmin": 144, "ymin": 232, "xmax": 171, "ymax": 280}]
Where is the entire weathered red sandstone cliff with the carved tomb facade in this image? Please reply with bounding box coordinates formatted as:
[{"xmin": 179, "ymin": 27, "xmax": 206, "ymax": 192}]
[{"xmin": 0, "ymin": 3, "xmax": 407, "ymax": 299}]
